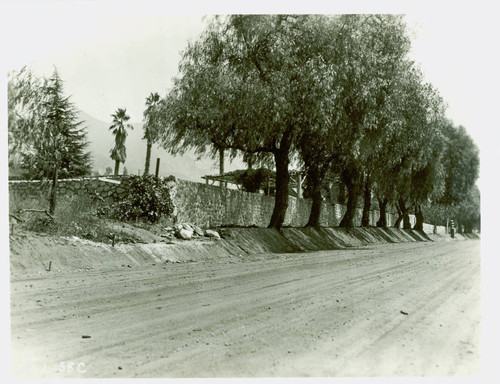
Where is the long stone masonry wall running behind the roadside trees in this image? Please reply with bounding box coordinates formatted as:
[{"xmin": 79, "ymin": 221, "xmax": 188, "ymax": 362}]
[{"xmin": 9, "ymin": 177, "xmax": 415, "ymax": 227}]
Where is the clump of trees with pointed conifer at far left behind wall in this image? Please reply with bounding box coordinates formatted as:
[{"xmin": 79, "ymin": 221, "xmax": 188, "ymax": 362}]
[{"xmin": 8, "ymin": 68, "xmax": 91, "ymax": 214}]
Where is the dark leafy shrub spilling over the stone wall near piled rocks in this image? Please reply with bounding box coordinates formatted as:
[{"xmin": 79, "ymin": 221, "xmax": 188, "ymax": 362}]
[{"xmin": 109, "ymin": 175, "xmax": 174, "ymax": 223}]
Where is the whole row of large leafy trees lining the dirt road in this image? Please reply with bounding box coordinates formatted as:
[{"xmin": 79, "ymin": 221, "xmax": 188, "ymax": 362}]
[{"xmin": 159, "ymin": 15, "xmax": 479, "ymax": 229}]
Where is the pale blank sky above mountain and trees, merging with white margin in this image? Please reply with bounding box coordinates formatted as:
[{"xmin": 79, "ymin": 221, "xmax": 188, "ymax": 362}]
[{"xmin": 0, "ymin": 0, "xmax": 500, "ymax": 184}]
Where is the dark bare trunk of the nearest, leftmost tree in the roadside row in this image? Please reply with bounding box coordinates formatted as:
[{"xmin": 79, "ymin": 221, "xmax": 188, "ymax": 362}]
[{"xmin": 268, "ymin": 146, "xmax": 290, "ymax": 230}]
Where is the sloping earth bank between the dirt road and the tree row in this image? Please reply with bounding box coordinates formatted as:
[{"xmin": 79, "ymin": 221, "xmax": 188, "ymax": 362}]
[{"xmin": 10, "ymin": 228, "xmax": 476, "ymax": 276}]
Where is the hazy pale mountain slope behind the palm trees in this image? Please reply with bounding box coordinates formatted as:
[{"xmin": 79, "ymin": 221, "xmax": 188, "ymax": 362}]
[{"xmin": 78, "ymin": 111, "xmax": 246, "ymax": 182}]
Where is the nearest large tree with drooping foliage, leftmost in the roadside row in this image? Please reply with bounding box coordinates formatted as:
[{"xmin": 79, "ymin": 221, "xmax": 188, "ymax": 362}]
[{"xmin": 164, "ymin": 15, "xmax": 332, "ymax": 228}]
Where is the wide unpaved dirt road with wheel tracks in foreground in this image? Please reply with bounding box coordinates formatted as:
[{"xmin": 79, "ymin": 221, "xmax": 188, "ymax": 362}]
[{"xmin": 11, "ymin": 240, "xmax": 481, "ymax": 378}]
